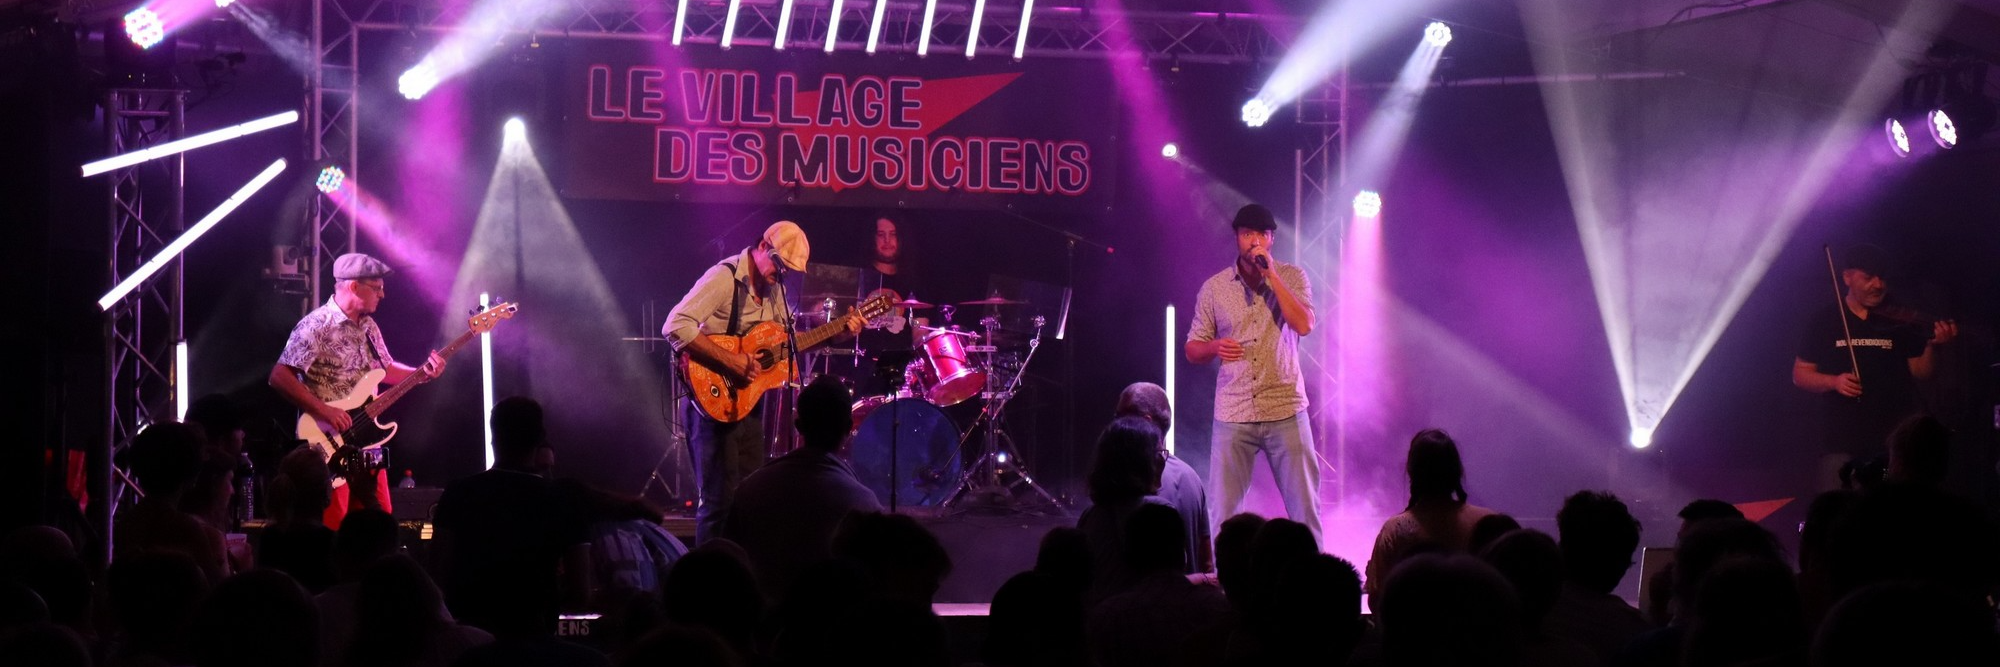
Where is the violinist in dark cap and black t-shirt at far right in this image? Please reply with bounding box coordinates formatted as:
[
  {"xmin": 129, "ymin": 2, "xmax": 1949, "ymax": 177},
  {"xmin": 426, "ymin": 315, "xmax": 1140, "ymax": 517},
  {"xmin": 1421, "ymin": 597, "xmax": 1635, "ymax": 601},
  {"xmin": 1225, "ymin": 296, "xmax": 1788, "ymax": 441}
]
[{"xmin": 1792, "ymin": 246, "xmax": 1958, "ymax": 489}]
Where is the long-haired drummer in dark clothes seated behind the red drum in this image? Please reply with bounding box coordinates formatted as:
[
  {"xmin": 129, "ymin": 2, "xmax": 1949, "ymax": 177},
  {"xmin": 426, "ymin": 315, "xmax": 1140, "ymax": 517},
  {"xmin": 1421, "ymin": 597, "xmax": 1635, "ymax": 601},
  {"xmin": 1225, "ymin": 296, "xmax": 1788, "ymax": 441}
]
[{"xmin": 852, "ymin": 212, "xmax": 926, "ymax": 397}]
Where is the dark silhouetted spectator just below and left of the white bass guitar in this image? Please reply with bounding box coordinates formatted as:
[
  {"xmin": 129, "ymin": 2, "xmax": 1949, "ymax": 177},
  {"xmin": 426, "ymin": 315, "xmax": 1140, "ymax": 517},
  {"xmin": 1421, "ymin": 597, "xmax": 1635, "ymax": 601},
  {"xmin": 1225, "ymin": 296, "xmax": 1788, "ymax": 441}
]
[{"xmin": 256, "ymin": 447, "xmax": 336, "ymax": 593}]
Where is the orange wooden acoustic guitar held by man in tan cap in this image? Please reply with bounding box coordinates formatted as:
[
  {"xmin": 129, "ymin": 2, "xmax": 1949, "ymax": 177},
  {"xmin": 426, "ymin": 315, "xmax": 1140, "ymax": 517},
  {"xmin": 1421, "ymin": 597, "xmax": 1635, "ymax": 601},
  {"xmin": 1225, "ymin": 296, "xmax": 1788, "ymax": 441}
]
[{"xmin": 680, "ymin": 294, "xmax": 894, "ymax": 423}]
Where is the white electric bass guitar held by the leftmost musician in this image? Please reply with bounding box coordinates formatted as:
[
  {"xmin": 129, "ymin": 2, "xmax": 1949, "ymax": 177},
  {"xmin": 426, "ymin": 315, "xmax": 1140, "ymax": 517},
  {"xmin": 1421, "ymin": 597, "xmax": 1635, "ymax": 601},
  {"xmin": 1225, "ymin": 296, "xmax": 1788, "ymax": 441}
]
[{"xmin": 298, "ymin": 304, "xmax": 520, "ymax": 487}]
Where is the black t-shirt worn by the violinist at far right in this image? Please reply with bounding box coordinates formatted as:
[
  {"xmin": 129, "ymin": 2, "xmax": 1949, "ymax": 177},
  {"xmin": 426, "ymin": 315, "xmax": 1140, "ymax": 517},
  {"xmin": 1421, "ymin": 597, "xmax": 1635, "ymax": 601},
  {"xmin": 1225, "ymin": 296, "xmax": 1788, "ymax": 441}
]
[{"xmin": 1798, "ymin": 308, "xmax": 1930, "ymax": 457}]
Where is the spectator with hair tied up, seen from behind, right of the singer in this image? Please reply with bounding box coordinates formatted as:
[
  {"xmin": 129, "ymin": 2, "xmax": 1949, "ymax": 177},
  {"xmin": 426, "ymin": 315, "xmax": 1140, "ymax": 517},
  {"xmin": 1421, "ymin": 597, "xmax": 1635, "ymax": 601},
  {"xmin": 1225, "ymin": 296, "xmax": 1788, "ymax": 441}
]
[{"xmin": 1366, "ymin": 429, "xmax": 1494, "ymax": 597}]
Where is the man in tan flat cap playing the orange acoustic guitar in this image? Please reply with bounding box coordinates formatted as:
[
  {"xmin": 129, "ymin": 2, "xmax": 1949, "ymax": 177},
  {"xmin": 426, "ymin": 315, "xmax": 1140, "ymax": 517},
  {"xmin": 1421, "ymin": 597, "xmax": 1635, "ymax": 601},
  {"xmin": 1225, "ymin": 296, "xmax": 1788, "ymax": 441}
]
[{"xmin": 660, "ymin": 220, "xmax": 866, "ymax": 543}]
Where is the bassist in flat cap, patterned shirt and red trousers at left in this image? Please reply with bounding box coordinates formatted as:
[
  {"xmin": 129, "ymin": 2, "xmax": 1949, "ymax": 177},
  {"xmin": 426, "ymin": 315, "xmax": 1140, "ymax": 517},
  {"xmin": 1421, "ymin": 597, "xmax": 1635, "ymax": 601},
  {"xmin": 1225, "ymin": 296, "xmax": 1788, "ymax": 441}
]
[{"xmin": 270, "ymin": 252, "xmax": 444, "ymax": 529}]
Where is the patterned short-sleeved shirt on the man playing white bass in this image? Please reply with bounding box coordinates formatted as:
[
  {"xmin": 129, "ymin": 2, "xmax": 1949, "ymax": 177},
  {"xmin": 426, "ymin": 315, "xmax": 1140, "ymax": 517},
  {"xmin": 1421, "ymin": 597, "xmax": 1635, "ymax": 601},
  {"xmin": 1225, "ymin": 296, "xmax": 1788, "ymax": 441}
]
[{"xmin": 278, "ymin": 298, "xmax": 396, "ymax": 401}]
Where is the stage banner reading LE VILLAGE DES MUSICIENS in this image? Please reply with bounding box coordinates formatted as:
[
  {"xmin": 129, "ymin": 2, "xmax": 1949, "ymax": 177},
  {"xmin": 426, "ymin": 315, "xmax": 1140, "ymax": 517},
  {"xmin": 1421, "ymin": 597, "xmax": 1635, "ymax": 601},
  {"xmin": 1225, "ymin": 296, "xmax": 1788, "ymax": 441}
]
[{"xmin": 556, "ymin": 40, "xmax": 1120, "ymax": 212}]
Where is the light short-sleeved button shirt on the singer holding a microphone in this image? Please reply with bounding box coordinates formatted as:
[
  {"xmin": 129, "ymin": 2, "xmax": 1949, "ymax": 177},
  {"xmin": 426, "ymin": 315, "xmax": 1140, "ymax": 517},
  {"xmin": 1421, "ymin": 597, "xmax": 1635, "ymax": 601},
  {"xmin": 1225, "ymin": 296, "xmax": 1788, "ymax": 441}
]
[{"xmin": 1188, "ymin": 260, "xmax": 1312, "ymax": 423}]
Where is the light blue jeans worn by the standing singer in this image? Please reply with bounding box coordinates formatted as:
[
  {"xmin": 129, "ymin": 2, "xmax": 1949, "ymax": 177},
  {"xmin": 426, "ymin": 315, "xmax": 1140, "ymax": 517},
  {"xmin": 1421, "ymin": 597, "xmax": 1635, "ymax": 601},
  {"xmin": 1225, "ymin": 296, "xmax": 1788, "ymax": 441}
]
[{"xmin": 1208, "ymin": 411, "xmax": 1320, "ymax": 537}]
